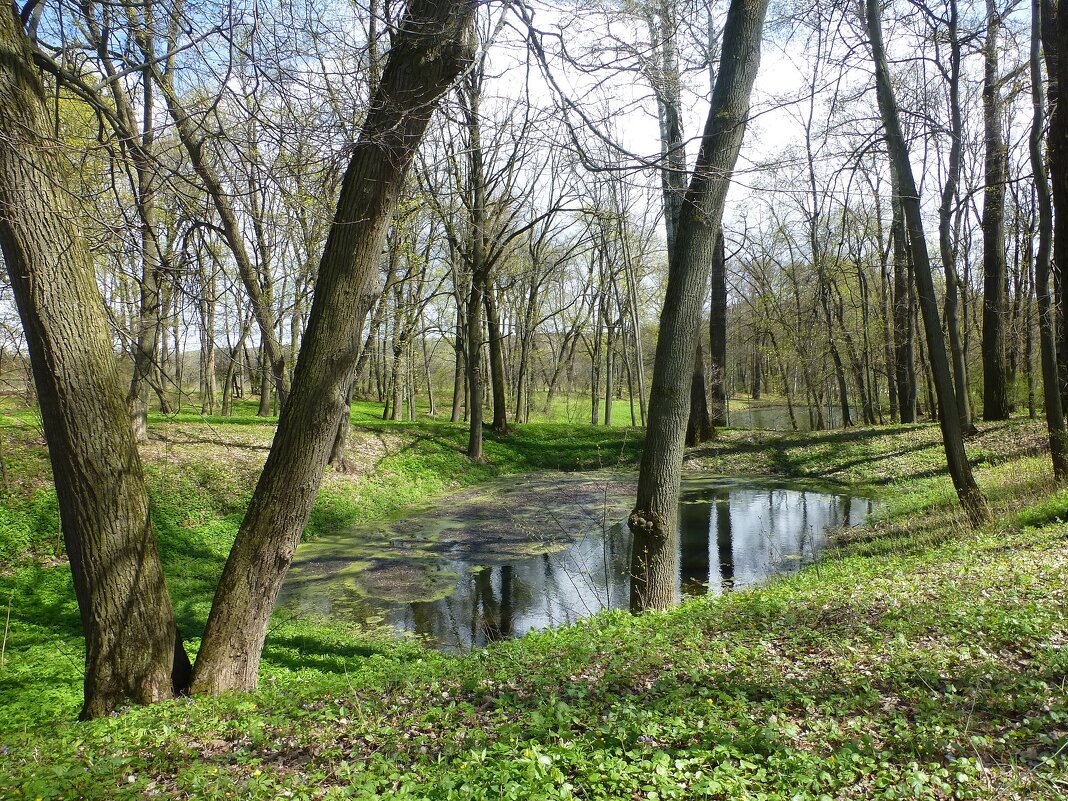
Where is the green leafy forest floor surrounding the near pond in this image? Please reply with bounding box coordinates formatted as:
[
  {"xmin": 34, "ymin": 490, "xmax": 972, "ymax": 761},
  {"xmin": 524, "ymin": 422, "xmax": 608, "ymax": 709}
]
[{"xmin": 0, "ymin": 405, "xmax": 1068, "ymax": 799}]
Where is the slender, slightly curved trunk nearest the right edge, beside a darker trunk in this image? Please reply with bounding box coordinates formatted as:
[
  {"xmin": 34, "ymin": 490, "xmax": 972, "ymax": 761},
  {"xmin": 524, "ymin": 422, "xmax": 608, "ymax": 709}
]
[{"xmin": 1030, "ymin": 0, "xmax": 1068, "ymax": 483}]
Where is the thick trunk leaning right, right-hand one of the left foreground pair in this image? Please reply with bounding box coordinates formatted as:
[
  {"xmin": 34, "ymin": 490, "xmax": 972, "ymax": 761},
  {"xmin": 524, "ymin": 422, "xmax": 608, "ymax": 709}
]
[{"xmin": 193, "ymin": 0, "xmax": 475, "ymax": 693}]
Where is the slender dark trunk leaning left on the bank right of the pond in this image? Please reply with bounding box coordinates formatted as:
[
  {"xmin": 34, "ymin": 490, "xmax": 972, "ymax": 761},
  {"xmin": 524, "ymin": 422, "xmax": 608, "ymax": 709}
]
[{"xmin": 864, "ymin": 0, "xmax": 989, "ymax": 524}]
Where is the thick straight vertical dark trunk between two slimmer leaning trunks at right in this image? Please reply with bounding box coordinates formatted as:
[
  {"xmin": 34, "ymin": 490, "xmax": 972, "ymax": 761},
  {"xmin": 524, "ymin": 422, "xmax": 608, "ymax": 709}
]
[{"xmin": 981, "ymin": 0, "xmax": 1009, "ymax": 421}]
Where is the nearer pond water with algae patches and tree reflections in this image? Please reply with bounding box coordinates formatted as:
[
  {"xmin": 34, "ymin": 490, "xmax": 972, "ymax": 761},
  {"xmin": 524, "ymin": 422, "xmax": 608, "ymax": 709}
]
[{"xmin": 281, "ymin": 472, "xmax": 875, "ymax": 649}]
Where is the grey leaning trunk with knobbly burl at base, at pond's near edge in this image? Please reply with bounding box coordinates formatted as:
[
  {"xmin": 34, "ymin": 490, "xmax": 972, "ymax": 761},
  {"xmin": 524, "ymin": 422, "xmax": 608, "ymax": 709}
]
[{"xmin": 628, "ymin": 0, "xmax": 768, "ymax": 610}]
